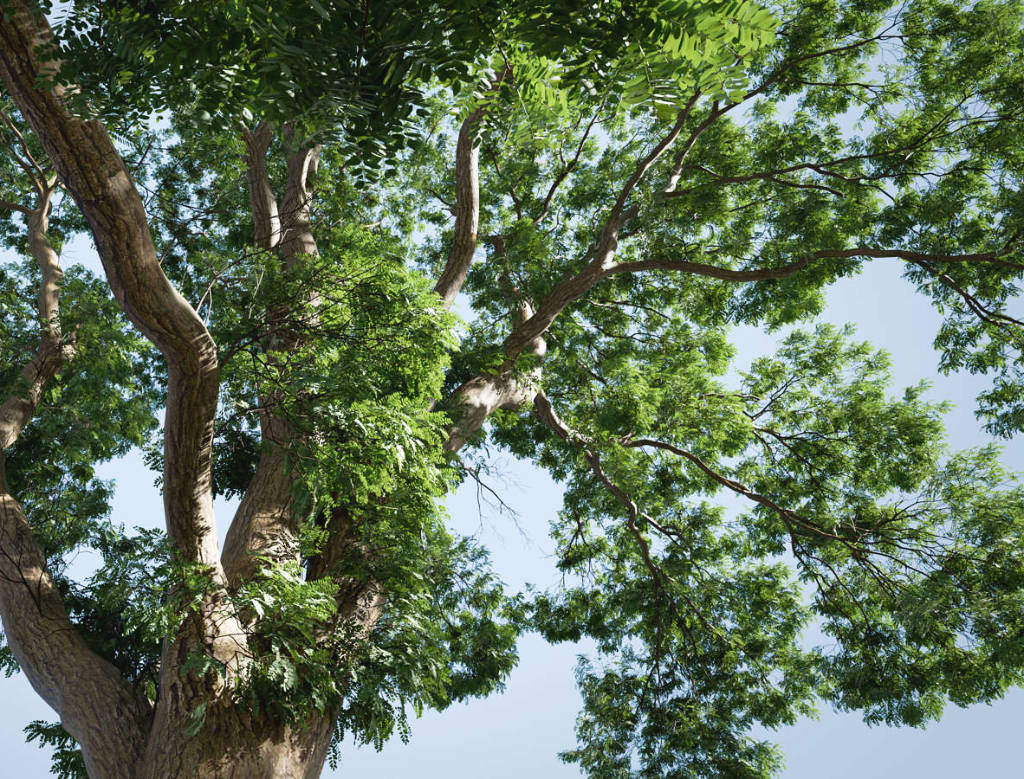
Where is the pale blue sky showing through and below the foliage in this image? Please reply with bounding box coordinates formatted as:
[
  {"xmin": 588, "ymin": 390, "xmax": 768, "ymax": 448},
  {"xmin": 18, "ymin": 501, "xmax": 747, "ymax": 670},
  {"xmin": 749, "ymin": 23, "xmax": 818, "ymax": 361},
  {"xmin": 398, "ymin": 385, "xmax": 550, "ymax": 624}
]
[{"xmin": 0, "ymin": 234, "xmax": 1024, "ymax": 779}]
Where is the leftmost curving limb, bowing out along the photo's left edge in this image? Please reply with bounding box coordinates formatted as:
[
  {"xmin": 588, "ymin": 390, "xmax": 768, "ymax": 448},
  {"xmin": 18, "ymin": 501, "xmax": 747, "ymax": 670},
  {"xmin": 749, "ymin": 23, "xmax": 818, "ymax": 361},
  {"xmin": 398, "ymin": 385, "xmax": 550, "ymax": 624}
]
[{"xmin": 0, "ymin": 177, "xmax": 152, "ymax": 778}]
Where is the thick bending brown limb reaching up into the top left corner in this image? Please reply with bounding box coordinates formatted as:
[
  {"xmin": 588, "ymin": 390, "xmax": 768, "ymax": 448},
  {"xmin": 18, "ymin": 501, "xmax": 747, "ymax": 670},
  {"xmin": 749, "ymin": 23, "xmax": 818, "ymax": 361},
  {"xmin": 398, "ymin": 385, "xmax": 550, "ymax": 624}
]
[{"xmin": 0, "ymin": 0, "xmax": 219, "ymax": 566}]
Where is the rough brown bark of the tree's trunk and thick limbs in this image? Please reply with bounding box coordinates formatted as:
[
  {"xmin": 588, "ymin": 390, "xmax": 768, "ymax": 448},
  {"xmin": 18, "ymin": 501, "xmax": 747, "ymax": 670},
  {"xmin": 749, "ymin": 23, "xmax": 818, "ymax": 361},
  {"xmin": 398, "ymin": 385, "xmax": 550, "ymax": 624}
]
[{"xmin": 0, "ymin": 2, "xmax": 651, "ymax": 779}]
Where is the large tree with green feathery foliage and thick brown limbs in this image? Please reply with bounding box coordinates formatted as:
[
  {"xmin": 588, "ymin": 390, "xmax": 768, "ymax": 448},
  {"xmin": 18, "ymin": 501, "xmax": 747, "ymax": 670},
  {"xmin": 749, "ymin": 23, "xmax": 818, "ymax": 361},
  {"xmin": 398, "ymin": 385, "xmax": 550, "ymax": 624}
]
[{"xmin": 0, "ymin": 0, "xmax": 1024, "ymax": 777}]
